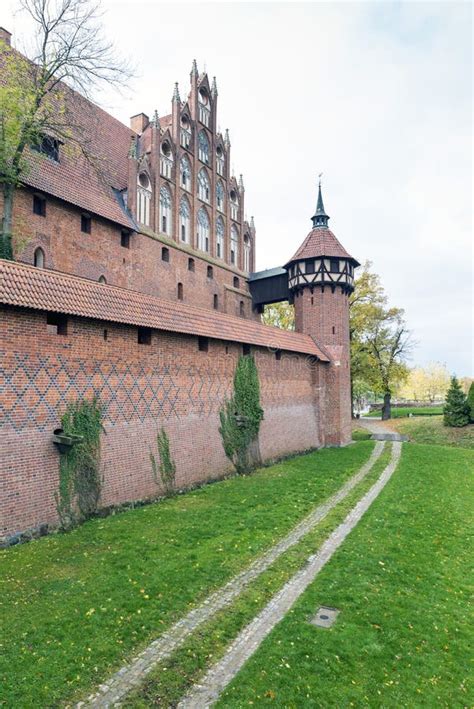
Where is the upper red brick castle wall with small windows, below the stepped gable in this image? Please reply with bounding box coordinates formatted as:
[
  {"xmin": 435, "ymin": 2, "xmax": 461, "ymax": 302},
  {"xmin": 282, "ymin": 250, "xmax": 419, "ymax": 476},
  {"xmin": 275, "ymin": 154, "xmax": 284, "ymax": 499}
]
[{"xmin": 0, "ymin": 189, "xmax": 260, "ymax": 320}]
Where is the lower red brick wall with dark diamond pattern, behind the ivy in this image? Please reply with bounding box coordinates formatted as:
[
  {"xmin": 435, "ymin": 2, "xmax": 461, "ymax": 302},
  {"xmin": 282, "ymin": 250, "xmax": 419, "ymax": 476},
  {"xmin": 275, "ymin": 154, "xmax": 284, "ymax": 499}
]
[{"xmin": 0, "ymin": 307, "xmax": 326, "ymax": 536}]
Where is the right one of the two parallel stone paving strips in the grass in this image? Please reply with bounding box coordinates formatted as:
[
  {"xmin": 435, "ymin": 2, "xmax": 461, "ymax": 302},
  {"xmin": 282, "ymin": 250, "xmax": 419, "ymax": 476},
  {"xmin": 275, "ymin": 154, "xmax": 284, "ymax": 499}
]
[{"xmin": 178, "ymin": 442, "xmax": 402, "ymax": 709}]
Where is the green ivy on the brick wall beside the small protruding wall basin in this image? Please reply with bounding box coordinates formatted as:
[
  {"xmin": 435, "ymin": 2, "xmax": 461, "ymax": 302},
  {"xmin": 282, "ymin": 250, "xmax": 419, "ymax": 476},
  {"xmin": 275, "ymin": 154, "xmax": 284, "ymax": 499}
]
[{"xmin": 56, "ymin": 398, "xmax": 103, "ymax": 529}]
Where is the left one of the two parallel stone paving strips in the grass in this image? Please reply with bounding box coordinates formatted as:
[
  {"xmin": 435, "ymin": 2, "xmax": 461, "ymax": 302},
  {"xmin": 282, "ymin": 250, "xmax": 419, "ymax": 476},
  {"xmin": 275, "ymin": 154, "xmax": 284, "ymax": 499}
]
[{"xmin": 76, "ymin": 442, "xmax": 385, "ymax": 709}]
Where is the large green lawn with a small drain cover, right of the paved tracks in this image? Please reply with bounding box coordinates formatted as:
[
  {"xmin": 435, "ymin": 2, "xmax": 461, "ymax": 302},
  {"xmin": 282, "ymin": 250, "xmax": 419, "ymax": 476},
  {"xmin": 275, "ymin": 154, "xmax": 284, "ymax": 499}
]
[{"xmin": 216, "ymin": 444, "xmax": 474, "ymax": 709}]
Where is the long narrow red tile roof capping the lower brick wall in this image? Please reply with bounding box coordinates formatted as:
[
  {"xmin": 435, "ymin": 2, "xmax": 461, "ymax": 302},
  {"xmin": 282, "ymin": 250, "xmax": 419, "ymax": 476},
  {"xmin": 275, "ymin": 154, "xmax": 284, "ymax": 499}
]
[{"xmin": 0, "ymin": 260, "xmax": 329, "ymax": 362}]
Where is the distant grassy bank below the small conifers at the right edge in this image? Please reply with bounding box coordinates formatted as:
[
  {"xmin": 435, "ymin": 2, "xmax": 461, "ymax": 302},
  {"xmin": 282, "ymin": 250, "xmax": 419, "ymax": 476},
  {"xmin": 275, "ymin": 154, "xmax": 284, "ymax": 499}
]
[{"xmin": 391, "ymin": 416, "xmax": 474, "ymax": 448}]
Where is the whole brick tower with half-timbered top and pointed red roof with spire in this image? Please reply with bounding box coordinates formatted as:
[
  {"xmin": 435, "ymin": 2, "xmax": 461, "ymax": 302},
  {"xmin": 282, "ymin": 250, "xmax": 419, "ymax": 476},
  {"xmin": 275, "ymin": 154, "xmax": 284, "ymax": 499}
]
[{"xmin": 285, "ymin": 182, "xmax": 360, "ymax": 445}]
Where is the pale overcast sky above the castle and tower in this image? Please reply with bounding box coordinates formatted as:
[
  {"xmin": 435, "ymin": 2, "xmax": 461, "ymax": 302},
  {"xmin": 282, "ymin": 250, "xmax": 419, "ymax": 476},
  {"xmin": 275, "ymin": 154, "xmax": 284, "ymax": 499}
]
[{"xmin": 0, "ymin": 0, "xmax": 474, "ymax": 376}]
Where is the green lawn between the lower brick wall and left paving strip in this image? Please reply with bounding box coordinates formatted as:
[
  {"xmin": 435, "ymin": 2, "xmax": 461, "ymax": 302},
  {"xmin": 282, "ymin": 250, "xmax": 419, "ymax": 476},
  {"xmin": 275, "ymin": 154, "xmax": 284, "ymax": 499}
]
[{"xmin": 0, "ymin": 441, "xmax": 374, "ymax": 709}]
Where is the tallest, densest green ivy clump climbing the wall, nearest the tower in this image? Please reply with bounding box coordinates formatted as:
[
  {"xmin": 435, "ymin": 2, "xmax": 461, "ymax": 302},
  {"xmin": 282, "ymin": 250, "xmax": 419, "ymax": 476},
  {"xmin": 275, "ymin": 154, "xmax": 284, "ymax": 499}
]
[{"xmin": 219, "ymin": 355, "xmax": 263, "ymax": 473}]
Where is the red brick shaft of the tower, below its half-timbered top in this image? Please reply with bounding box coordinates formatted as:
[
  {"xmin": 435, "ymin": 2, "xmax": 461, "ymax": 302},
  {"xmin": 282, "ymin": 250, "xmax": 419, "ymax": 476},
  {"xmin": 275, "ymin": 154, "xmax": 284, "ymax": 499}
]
[{"xmin": 294, "ymin": 286, "xmax": 351, "ymax": 445}]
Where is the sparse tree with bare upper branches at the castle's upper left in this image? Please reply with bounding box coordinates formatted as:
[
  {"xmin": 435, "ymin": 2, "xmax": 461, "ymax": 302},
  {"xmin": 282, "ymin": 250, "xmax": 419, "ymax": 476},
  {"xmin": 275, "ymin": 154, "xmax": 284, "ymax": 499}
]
[{"xmin": 0, "ymin": 0, "xmax": 132, "ymax": 258}]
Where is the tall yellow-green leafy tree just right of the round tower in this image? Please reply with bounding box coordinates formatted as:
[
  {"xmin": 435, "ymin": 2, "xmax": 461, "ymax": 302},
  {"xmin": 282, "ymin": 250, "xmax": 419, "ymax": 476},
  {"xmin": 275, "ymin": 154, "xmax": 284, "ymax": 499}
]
[{"xmin": 349, "ymin": 261, "xmax": 411, "ymax": 419}]
